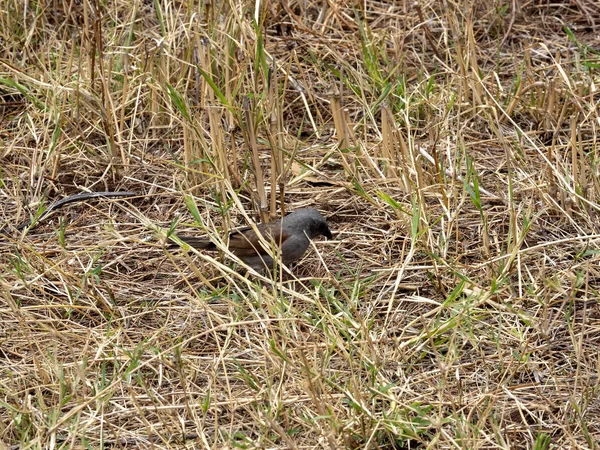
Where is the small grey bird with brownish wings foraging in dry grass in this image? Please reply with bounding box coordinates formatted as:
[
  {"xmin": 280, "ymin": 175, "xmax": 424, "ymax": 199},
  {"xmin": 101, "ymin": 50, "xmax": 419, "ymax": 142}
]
[{"xmin": 169, "ymin": 208, "xmax": 332, "ymax": 272}]
